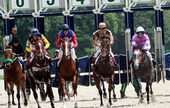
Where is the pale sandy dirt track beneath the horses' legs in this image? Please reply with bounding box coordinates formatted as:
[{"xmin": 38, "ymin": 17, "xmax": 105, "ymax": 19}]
[{"xmin": 0, "ymin": 80, "xmax": 170, "ymax": 108}]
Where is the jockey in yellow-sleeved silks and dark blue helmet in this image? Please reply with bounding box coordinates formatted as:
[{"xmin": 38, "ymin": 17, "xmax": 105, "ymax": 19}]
[{"xmin": 25, "ymin": 28, "xmax": 50, "ymax": 62}]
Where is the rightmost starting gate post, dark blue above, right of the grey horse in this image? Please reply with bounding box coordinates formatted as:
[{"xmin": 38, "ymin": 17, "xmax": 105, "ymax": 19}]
[{"xmin": 154, "ymin": 0, "xmax": 165, "ymax": 82}]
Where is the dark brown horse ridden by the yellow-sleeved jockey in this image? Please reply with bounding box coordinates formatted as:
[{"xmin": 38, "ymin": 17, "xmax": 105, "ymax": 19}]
[{"xmin": 28, "ymin": 40, "xmax": 55, "ymax": 108}]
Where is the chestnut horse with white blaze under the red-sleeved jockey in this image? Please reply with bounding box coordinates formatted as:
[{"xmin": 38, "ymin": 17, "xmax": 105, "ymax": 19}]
[{"xmin": 58, "ymin": 37, "xmax": 78, "ymax": 104}]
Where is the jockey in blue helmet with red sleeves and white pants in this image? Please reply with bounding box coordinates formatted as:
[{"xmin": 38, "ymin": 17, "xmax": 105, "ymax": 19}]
[{"xmin": 55, "ymin": 24, "xmax": 78, "ymax": 69}]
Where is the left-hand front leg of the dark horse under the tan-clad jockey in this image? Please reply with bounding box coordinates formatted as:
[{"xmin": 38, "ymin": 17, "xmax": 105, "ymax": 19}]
[{"xmin": 94, "ymin": 75, "xmax": 103, "ymax": 106}]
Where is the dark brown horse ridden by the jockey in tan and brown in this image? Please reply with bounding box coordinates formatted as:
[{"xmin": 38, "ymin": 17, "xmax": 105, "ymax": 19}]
[{"xmin": 93, "ymin": 38, "xmax": 116, "ymax": 106}]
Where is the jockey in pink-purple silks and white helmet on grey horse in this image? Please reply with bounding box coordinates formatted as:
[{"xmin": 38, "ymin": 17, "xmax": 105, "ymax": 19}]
[{"xmin": 131, "ymin": 26, "xmax": 153, "ymax": 61}]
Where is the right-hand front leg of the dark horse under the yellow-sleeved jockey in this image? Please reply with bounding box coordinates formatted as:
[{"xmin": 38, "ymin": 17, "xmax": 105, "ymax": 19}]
[{"xmin": 46, "ymin": 80, "xmax": 55, "ymax": 108}]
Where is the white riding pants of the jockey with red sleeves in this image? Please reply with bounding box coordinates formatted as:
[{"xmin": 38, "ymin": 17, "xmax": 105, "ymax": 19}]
[{"xmin": 57, "ymin": 48, "xmax": 77, "ymax": 66}]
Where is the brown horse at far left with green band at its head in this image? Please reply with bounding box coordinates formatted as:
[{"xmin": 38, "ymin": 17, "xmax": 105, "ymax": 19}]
[{"xmin": 4, "ymin": 49, "xmax": 27, "ymax": 108}]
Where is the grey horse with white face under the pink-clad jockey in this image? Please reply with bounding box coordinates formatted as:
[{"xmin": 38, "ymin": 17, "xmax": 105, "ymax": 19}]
[{"xmin": 132, "ymin": 48, "xmax": 154, "ymax": 104}]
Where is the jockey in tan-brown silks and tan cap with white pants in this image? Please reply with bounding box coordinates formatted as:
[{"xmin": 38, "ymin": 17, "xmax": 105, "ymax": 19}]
[{"xmin": 93, "ymin": 22, "xmax": 117, "ymax": 65}]
